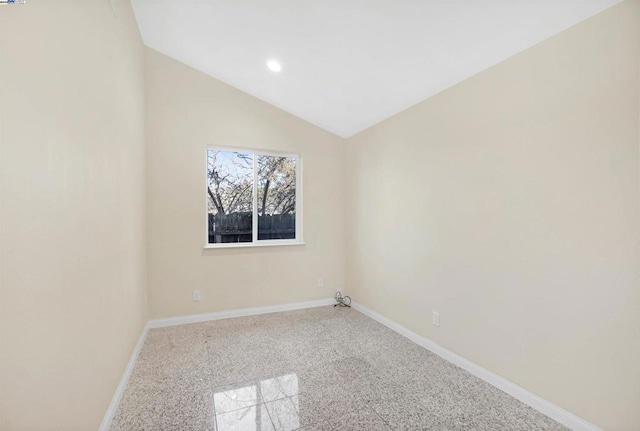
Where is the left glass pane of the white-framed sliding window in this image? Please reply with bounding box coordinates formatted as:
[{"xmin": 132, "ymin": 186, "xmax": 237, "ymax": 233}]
[{"xmin": 207, "ymin": 150, "xmax": 253, "ymax": 244}]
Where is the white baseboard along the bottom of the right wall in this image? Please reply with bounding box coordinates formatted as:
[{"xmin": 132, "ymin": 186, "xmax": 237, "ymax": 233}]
[{"xmin": 351, "ymin": 301, "xmax": 602, "ymax": 431}]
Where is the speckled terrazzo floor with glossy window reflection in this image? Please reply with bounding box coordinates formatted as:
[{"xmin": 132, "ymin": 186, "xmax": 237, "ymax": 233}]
[{"xmin": 111, "ymin": 306, "xmax": 566, "ymax": 431}]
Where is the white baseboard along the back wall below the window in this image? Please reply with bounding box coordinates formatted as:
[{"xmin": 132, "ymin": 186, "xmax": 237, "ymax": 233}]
[{"xmin": 148, "ymin": 298, "xmax": 335, "ymax": 328}]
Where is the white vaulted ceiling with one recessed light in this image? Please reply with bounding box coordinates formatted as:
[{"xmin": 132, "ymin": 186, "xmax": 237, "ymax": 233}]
[{"xmin": 133, "ymin": 0, "xmax": 621, "ymax": 137}]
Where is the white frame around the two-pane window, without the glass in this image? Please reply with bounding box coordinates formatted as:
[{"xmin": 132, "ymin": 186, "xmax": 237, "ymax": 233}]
[{"xmin": 203, "ymin": 145, "xmax": 304, "ymax": 249}]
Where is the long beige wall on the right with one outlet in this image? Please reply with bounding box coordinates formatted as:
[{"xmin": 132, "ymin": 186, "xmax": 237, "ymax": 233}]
[{"xmin": 347, "ymin": 0, "xmax": 640, "ymax": 430}]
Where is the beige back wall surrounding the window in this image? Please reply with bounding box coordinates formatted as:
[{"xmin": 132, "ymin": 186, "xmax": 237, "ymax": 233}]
[{"xmin": 146, "ymin": 49, "xmax": 345, "ymax": 318}]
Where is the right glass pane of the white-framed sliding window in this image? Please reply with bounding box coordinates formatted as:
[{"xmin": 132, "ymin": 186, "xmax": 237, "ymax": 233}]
[{"xmin": 257, "ymin": 156, "xmax": 296, "ymax": 240}]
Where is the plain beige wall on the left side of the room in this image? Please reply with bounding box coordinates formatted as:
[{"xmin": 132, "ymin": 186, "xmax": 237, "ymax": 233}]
[{"xmin": 0, "ymin": 0, "xmax": 147, "ymax": 431}]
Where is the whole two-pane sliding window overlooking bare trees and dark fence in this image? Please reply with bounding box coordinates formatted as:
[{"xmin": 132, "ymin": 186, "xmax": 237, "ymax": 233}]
[{"xmin": 207, "ymin": 148, "xmax": 302, "ymax": 247}]
